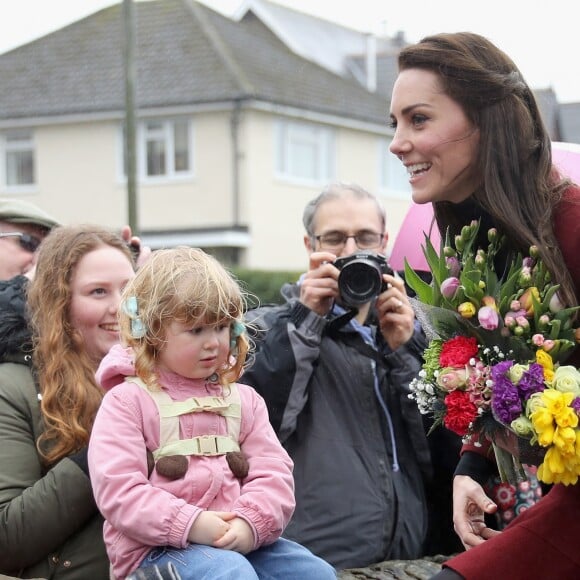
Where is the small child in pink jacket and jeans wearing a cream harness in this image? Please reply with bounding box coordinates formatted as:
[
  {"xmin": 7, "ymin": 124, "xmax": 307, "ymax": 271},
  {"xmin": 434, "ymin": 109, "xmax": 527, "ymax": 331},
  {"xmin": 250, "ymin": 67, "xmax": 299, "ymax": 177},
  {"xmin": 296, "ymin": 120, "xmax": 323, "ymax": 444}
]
[{"xmin": 89, "ymin": 247, "xmax": 336, "ymax": 580}]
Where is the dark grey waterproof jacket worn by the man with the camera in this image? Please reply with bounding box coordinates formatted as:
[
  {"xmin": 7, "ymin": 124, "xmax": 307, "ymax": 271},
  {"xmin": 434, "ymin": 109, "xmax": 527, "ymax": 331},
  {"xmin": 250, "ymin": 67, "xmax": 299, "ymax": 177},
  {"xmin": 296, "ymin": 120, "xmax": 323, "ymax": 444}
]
[{"xmin": 240, "ymin": 285, "xmax": 431, "ymax": 569}]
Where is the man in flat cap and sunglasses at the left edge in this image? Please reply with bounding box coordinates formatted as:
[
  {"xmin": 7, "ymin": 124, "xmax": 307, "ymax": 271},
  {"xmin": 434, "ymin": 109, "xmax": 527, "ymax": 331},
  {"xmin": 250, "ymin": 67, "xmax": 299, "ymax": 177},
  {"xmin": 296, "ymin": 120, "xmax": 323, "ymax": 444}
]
[{"xmin": 0, "ymin": 199, "xmax": 58, "ymax": 280}]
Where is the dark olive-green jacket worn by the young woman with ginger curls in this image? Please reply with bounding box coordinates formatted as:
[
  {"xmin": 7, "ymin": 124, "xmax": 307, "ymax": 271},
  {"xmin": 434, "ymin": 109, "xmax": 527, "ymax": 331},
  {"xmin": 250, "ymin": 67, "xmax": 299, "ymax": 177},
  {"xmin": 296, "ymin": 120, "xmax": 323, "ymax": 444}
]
[{"xmin": 0, "ymin": 277, "xmax": 109, "ymax": 580}]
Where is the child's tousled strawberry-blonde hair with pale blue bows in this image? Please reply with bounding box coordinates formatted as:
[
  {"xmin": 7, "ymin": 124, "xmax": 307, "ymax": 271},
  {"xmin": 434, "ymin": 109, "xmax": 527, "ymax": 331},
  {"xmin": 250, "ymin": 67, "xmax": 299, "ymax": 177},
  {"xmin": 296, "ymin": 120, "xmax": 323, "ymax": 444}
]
[{"xmin": 119, "ymin": 246, "xmax": 250, "ymax": 388}]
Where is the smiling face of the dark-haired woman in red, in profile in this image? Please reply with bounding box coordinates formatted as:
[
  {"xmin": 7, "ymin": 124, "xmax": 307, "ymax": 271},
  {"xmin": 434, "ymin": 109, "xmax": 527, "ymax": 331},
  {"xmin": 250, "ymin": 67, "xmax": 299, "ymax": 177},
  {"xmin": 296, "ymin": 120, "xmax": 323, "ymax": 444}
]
[{"xmin": 390, "ymin": 68, "xmax": 480, "ymax": 203}]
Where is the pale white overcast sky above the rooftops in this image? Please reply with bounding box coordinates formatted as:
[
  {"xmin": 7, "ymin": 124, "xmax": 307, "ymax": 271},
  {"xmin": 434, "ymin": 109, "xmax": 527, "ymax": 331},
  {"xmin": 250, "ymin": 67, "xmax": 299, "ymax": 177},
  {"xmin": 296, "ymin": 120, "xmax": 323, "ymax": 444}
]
[{"xmin": 0, "ymin": 0, "xmax": 580, "ymax": 103}]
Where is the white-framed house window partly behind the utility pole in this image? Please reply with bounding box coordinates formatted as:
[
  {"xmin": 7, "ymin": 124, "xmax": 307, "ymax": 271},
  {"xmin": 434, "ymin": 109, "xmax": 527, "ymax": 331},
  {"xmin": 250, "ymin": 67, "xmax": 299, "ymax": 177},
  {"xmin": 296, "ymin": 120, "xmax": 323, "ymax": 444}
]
[{"xmin": 122, "ymin": 119, "xmax": 193, "ymax": 180}]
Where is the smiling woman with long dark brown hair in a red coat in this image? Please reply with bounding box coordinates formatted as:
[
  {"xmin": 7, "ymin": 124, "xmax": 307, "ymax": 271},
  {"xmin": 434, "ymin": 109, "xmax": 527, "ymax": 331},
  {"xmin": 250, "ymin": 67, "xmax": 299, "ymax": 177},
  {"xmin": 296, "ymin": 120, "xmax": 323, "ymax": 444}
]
[{"xmin": 390, "ymin": 32, "xmax": 580, "ymax": 580}]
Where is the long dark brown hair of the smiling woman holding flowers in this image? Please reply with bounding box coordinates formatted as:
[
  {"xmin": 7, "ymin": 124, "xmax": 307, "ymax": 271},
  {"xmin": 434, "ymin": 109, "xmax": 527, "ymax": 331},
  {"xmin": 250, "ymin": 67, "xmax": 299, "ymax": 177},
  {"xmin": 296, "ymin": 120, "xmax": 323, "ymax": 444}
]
[{"xmin": 398, "ymin": 32, "xmax": 577, "ymax": 305}]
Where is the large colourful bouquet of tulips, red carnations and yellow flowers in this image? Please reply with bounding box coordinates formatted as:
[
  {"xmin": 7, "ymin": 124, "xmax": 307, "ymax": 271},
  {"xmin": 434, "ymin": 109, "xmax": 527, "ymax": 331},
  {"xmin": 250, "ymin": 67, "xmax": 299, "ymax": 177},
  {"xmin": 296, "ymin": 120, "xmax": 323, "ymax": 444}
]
[{"xmin": 405, "ymin": 221, "xmax": 580, "ymax": 484}]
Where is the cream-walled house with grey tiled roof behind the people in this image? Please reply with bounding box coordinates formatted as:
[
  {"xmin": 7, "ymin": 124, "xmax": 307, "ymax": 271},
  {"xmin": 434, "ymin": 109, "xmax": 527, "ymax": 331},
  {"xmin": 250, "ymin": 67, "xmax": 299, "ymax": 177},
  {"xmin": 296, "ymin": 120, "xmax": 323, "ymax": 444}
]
[{"xmin": 0, "ymin": 0, "xmax": 420, "ymax": 270}]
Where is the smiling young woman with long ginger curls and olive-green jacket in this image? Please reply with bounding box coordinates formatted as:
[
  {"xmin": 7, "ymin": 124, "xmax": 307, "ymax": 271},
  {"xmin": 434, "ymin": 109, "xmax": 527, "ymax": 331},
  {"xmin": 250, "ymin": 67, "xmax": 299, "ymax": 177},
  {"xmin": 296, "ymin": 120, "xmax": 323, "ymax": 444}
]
[{"xmin": 0, "ymin": 225, "xmax": 134, "ymax": 580}]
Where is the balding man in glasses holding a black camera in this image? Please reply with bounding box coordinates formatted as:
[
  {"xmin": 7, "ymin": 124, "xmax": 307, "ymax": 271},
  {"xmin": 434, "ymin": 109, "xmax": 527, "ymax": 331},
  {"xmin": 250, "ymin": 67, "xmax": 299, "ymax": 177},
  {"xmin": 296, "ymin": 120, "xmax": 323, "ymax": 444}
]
[{"xmin": 241, "ymin": 184, "xmax": 431, "ymax": 569}]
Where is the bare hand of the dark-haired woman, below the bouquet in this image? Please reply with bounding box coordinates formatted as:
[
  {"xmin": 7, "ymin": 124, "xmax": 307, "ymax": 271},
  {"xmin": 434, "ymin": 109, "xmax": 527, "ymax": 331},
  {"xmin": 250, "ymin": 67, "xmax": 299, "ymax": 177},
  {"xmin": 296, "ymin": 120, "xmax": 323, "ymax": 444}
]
[{"xmin": 453, "ymin": 475, "xmax": 501, "ymax": 550}]
